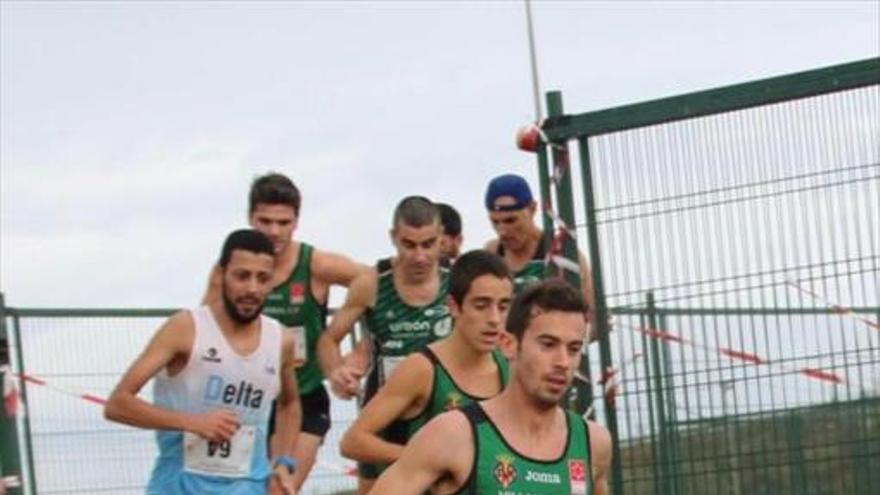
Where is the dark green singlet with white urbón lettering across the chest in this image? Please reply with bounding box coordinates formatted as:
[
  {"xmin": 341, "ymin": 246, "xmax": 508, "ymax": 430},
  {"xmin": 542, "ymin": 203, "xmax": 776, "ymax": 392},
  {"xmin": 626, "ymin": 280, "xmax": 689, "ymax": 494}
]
[{"xmin": 366, "ymin": 268, "xmax": 452, "ymax": 386}]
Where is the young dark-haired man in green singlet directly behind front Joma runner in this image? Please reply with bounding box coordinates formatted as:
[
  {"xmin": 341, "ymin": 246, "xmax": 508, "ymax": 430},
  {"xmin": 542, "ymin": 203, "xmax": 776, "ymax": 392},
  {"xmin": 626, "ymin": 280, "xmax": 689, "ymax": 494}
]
[{"xmin": 340, "ymin": 250, "xmax": 513, "ymax": 470}]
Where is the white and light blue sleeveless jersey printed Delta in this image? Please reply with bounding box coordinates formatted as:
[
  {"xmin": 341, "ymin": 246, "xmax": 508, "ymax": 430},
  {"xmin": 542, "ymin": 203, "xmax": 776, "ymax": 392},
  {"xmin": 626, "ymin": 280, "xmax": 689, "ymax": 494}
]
[{"xmin": 147, "ymin": 306, "xmax": 281, "ymax": 495}]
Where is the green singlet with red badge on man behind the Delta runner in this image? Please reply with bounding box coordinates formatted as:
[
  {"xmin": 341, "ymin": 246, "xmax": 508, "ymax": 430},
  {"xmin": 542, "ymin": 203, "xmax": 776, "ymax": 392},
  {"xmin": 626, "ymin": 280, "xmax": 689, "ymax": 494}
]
[{"xmin": 263, "ymin": 243, "xmax": 327, "ymax": 395}]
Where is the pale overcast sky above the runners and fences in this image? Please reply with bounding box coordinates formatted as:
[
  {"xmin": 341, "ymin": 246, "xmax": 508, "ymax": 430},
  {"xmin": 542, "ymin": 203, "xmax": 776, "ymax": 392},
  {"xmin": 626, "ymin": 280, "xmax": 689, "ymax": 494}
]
[{"xmin": 0, "ymin": 0, "xmax": 880, "ymax": 307}]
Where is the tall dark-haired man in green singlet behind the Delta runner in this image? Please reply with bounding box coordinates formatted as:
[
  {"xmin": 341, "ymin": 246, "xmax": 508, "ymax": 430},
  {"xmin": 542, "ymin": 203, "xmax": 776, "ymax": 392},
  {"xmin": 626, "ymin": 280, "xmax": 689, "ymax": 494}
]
[{"xmin": 204, "ymin": 173, "xmax": 367, "ymax": 489}]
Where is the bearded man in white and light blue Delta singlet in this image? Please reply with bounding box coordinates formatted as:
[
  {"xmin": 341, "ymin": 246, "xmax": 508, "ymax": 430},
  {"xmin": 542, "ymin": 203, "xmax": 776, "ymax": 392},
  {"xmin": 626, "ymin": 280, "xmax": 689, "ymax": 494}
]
[{"xmin": 104, "ymin": 230, "xmax": 301, "ymax": 495}]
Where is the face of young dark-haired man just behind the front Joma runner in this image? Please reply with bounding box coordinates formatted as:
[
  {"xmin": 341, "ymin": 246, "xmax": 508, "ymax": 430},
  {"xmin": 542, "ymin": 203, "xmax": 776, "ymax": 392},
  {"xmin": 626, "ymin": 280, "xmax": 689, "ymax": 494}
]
[{"xmin": 449, "ymin": 274, "xmax": 513, "ymax": 352}]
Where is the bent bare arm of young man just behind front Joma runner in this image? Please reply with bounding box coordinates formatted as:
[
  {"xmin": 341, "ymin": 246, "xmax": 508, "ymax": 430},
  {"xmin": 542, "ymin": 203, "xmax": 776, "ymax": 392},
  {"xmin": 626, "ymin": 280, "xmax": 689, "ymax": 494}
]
[{"xmin": 339, "ymin": 354, "xmax": 433, "ymax": 464}]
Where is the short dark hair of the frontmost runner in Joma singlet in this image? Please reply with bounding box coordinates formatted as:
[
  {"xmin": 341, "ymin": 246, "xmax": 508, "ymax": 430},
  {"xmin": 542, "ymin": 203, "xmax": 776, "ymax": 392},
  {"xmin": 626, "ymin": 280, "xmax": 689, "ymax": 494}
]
[{"xmin": 506, "ymin": 278, "xmax": 589, "ymax": 341}]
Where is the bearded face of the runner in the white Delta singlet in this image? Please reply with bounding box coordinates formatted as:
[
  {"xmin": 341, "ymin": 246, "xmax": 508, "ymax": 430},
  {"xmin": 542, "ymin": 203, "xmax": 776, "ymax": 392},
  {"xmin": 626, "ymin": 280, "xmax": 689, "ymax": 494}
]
[{"xmin": 223, "ymin": 249, "xmax": 275, "ymax": 324}]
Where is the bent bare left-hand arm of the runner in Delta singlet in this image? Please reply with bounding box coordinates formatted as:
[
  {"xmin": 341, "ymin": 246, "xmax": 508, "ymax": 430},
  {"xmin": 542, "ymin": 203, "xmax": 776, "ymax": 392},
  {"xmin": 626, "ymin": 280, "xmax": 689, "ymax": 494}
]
[{"xmin": 104, "ymin": 311, "xmax": 239, "ymax": 441}]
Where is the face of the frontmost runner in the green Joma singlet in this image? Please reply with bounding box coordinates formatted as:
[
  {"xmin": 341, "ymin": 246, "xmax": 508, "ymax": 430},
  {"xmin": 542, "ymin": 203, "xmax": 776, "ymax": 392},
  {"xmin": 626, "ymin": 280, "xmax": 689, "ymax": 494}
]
[{"xmin": 513, "ymin": 311, "xmax": 587, "ymax": 408}]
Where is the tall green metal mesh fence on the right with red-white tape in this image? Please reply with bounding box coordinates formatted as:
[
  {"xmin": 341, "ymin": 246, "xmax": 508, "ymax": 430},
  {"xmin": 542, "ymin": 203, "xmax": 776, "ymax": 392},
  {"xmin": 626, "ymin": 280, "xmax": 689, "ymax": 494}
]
[{"xmin": 538, "ymin": 59, "xmax": 880, "ymax": 495}]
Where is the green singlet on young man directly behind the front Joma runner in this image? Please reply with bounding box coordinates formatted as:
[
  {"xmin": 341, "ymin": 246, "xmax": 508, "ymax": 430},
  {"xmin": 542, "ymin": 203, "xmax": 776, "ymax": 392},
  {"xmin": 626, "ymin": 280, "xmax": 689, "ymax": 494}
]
[{"xmin": 407, "ymin": 347, "xmax": 510, "ymax": 437}]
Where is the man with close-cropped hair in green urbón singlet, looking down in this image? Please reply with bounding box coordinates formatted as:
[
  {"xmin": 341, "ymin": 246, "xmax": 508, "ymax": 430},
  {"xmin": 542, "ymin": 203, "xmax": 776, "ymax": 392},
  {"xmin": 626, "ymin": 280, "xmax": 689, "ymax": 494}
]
[{"xmin": 318, "ymin": 196, "xmax": 452, "ymax": 494}]
